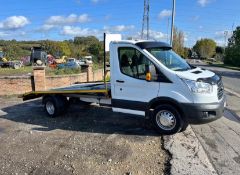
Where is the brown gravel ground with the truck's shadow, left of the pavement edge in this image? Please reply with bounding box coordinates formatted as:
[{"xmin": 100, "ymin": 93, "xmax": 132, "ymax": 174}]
[{"xmin": 0, "ymin": 97, "xmax": 169, "ymax": 175}]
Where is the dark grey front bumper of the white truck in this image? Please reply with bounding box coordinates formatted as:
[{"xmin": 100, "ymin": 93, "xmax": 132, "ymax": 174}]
[{"xmin": 181, "ymin": 96, "xmax": 226, "ymax": 124}]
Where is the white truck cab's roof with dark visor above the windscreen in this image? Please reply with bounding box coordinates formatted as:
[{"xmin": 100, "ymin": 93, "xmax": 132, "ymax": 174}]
[{"xmin": 112, "ymin": 40, "xmax": 172, "ymax": 49}]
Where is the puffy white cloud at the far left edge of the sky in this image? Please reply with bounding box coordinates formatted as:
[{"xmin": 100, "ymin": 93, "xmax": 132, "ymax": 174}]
[{"xmin": 0, "ymin": 16, "xmax": 30, "ymax": 30}]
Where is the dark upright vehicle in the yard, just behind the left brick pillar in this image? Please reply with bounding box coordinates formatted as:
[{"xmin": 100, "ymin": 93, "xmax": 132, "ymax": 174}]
[{"xmin": 30, "ymin": 47, "xmax": 48, "ymax": 65}]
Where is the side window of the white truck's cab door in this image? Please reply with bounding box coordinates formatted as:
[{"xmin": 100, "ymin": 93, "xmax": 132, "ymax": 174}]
[{"xmin": 118, "ymin": 47, "xmax": 158, "ymax": 81}]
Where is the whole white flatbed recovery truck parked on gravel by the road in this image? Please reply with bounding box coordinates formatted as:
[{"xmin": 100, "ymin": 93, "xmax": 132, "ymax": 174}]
[{"xmin": 22, "ymin": 40, "xmax": 226, "ymax": 134}]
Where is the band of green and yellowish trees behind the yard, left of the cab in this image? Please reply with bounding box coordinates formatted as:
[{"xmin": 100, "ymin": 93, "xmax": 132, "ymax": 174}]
[{"xmin": 0, "ymin": 36, "xmax": 103, "ymax": 62}]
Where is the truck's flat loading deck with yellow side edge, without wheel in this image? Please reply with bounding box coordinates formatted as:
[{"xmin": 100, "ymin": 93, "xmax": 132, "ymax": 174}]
[{"xmin": 19, "ymin": 82, "xmax": 111, "ymax": 101}]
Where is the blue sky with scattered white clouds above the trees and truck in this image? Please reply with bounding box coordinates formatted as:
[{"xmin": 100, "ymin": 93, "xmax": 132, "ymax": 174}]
[{"xmin": 0, "ymin": 0, "xmax": 240, "ymax": 47}]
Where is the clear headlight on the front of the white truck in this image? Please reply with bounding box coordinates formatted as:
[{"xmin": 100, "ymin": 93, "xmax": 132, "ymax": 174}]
[{"xmin": 182, "ymin": 79, "xmax": 213, "ymax": 94}]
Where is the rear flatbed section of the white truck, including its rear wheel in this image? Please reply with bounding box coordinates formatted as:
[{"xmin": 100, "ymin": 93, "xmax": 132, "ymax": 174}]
[{"xmin": 19, "ymin": 82, "xmax": 111, "ymax": 117}]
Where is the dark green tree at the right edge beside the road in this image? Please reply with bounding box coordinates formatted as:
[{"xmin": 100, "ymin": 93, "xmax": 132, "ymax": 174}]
[{"xmin": 224, "ymin": 26, "xmax": 240, "ymax": 66}]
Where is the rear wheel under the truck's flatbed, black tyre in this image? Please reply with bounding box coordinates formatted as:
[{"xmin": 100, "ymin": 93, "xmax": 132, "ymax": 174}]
[{"xmin": 43, "ymin": 96, "xmax": 68, "ymax": 118}]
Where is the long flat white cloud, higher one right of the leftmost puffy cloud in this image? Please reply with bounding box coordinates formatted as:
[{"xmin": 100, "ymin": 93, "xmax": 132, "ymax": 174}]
[{"xmin": 45, "ymin": 14, "xmax": 91, "ymax": 25}]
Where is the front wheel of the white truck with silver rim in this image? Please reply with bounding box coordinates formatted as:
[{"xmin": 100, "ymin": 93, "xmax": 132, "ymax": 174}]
[{"xmin": 151, "ymin": 104, "xmax": 184, "ymax": 135}]
